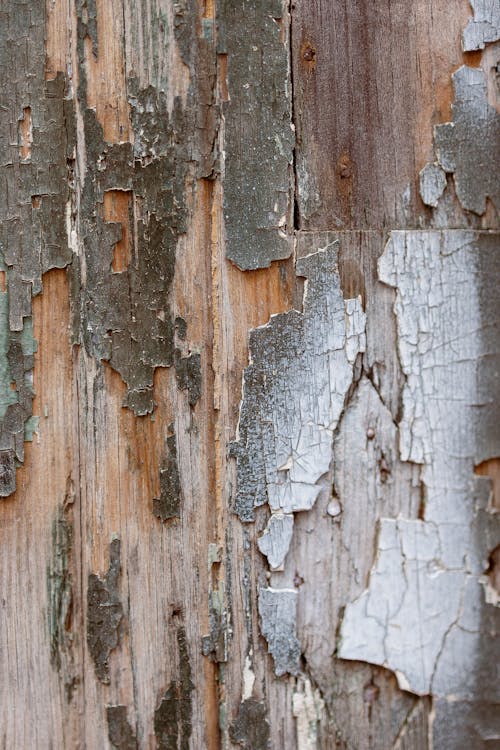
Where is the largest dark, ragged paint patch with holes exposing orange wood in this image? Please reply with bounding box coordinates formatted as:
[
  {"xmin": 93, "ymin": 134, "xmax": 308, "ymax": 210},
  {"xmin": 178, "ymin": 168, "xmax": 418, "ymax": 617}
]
[{"xmin": 72, "ymin": 0, "xmax": 217, "ymax": 415}]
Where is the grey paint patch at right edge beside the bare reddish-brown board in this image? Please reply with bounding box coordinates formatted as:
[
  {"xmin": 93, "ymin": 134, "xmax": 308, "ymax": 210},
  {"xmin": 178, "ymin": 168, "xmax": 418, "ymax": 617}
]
[{"xmin": 434, "ymin": 65, "xmax": 500, "ymax": 215}]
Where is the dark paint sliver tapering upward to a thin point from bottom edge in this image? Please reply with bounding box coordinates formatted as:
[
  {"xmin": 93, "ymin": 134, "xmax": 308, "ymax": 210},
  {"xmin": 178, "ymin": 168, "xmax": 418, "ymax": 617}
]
[{"xmin": 154, "ymin": 627, "xmax": 194, "ymax": 750}]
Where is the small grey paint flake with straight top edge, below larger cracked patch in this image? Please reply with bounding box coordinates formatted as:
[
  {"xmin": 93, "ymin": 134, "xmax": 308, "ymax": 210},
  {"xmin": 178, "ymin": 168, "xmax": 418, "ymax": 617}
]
[{"xmin": 259, "ymin": 587, "xmax": 300, "ymax": 677}]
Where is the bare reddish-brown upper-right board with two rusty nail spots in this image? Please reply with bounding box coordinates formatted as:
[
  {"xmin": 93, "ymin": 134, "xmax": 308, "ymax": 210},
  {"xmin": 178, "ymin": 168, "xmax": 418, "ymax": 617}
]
[{"xmin": 292, "ymin": 0, "xmax": 492, "ymax": 229}]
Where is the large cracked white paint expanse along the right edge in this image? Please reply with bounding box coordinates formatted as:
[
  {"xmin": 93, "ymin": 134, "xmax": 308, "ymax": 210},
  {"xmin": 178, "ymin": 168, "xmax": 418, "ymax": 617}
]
[{"xmin": 338, "ymin": 230, "xmax": 500, "ymax": 748}]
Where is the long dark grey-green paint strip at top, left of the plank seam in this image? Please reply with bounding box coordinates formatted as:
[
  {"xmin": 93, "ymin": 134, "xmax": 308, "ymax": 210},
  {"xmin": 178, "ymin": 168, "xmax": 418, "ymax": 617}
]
[{"xmin": 217, "ymin": 0, "xmax": 294, "ymax": 270}]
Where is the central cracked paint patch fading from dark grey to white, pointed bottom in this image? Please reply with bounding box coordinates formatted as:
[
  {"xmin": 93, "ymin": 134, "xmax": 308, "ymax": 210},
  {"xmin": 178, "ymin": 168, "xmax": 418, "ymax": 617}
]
[{"xmin": 231, "ymin": 242, "xmax": 365, "ymax": 568}]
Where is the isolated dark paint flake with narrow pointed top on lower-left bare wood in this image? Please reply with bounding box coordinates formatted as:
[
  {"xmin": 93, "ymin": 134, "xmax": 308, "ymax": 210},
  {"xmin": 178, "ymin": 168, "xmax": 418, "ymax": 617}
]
[{"xmin": 87, "ymin": 539, "xmax": 123, "ymax": 684}]
